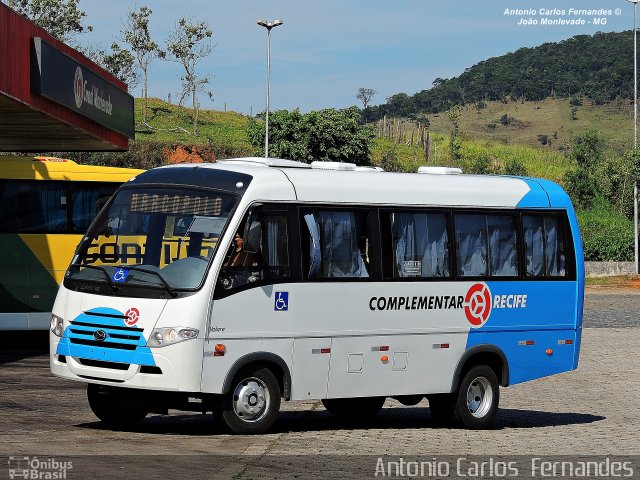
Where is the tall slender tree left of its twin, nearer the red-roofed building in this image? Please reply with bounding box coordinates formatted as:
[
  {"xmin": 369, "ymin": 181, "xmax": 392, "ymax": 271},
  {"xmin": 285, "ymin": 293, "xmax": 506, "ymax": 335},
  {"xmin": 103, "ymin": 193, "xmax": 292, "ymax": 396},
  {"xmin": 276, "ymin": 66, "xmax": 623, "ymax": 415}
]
[{"xmin": 118, "ymin": 6, "xmax": 165, "ymax": 122}]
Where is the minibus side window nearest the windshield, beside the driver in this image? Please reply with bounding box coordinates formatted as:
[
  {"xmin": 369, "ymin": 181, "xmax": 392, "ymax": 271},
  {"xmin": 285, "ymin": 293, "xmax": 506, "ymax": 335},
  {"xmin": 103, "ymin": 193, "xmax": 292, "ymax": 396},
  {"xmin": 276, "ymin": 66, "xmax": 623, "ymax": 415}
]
[{"xmin": 219, "ymin": 207, "xmax": 291, "ymax": 290}]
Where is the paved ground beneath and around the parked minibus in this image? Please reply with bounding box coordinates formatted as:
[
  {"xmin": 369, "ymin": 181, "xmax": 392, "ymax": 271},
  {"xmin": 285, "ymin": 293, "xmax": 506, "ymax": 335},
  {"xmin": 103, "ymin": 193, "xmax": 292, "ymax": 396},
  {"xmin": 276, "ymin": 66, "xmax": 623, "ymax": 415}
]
[{"xmin": 0, "ymin": 292, "xmax": 640, "ymax": 478}]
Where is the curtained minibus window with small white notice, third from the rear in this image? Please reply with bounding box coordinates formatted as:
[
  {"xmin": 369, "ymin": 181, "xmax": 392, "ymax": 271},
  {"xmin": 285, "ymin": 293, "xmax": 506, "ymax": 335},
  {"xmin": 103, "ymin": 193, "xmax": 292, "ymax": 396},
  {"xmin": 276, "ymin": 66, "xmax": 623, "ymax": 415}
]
[{"xmin": 383, "ymin": 212, "xmax": 450, "ymax": 278}]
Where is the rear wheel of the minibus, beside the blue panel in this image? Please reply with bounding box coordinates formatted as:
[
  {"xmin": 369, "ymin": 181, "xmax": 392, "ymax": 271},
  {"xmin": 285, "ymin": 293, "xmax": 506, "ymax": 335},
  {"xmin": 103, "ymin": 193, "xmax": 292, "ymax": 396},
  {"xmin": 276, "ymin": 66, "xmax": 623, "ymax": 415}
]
[{"xmin": 453, "ymin": 365, "xmax": 500, "ymax": 430}]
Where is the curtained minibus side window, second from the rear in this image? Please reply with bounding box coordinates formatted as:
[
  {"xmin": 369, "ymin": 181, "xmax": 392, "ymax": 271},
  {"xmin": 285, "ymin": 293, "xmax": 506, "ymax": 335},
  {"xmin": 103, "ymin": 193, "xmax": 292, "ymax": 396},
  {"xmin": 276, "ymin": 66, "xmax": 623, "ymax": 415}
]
[{"xmin": 454, "ymin": 214, "xmax": 518, "ymax": 277}]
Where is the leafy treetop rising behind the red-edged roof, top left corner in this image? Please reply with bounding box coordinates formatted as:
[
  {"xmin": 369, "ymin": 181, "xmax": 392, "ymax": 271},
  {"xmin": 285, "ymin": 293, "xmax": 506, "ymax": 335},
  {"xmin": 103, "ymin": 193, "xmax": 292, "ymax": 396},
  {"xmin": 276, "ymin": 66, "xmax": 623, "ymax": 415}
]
[{"xmin": 6, "ymin": 0, "xmax": 93, "ymax": 43}]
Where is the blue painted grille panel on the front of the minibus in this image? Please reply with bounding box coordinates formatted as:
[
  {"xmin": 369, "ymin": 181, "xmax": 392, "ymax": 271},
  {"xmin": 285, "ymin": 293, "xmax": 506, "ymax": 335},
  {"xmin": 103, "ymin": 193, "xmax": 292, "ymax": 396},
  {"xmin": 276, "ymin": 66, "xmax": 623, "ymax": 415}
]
[{"xmin": 56, "ymin": 308, "xmax": 156, "ymax": 366}]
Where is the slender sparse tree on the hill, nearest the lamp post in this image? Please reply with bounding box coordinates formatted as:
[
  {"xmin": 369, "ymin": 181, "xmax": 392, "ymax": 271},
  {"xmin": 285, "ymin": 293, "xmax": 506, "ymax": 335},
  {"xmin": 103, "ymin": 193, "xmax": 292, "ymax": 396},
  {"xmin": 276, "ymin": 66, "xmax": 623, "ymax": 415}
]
[{"xmin": 166, "ymin": 18, "xmax": 213, "ymax": 134}]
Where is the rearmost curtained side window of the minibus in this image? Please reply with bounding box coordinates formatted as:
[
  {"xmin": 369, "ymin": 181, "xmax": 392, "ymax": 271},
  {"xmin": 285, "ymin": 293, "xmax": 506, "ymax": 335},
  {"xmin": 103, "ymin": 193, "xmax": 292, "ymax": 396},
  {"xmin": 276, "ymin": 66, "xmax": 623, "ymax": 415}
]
[{"xmin": 522, "ymin": 215, "xmax": 567, "ymax": 277}]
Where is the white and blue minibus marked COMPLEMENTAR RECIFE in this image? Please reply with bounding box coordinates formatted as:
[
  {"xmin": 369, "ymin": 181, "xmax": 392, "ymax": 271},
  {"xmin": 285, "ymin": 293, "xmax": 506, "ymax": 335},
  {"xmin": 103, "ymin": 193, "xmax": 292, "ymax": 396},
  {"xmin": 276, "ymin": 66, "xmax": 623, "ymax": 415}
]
[{"xmin": 50, "ymin": 158, "xmax": 584, "ymax": 434}]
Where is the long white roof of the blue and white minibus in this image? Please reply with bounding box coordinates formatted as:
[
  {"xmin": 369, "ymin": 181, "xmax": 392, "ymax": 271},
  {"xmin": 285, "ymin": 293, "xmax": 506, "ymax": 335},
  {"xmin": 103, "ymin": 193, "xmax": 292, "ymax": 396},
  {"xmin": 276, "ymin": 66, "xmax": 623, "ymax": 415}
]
[{"xmin": 186, "ymin": 158, "xmax": 531, "ymax": 208}]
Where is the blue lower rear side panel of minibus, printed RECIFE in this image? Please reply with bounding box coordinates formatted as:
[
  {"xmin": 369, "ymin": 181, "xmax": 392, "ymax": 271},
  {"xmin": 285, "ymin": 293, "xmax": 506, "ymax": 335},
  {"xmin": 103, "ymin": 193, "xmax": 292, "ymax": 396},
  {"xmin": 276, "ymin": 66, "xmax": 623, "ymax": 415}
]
[{"xmin": 467, "ymin": 281, "xmax": 580, "ymax": 384}]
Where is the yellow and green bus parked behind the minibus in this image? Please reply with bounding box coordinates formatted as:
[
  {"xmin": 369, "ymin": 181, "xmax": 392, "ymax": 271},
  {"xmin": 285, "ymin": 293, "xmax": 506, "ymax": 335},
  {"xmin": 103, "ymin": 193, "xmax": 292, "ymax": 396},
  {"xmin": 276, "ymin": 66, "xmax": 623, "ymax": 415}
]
[{"xmin": 0, "ymin": 156, "xmax": 143, "ymax": 330}]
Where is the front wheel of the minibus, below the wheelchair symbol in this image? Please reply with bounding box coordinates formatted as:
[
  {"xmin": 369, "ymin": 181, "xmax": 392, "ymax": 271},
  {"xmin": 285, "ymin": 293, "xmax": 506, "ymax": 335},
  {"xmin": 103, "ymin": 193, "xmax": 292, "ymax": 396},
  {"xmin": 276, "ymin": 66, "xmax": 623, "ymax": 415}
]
[{"xmin": 221, "ymin": 367, "xmax": 282, "ymax": 435}]
